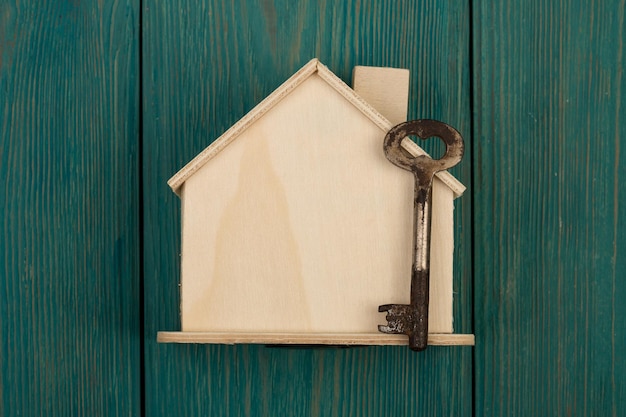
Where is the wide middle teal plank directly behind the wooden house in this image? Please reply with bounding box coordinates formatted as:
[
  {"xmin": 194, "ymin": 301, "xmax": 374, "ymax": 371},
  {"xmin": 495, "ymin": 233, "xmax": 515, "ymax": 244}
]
[{"xmin": 143, "ymin": 0, "xmax": 472, "ymax": 416}]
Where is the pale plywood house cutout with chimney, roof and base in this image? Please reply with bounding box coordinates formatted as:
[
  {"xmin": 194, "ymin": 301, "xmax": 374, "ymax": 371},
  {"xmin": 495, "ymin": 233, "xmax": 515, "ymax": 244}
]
[{"xmin": 158, "ymin": 59, "xmax": 473, "ymax": 344}]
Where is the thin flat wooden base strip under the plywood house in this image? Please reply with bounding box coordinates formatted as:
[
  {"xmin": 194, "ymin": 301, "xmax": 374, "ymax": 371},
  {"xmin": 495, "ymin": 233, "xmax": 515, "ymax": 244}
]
[{"xmin": 157, "ymin": 332, "xmax": 475, "ymax": 346}]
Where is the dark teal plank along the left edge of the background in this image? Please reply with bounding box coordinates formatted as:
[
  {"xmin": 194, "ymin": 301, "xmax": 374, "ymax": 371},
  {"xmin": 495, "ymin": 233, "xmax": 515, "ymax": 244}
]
[{"xmin": 0, "ymin": 0, "xmax": 141, "ymax": 416}]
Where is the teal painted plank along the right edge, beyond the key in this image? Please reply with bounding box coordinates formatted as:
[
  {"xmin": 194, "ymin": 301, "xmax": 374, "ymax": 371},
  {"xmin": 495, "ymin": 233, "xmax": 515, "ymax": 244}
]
[{"xmin": 473, "ymin": 0, "xmax": 626, "ymax": 416}]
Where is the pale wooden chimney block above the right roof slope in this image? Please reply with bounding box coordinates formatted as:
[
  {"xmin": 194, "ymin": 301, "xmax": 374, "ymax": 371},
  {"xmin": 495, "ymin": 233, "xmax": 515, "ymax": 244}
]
[{"xmin": 352, "ymin": 66, "xmax": 409, "ymax": 125}]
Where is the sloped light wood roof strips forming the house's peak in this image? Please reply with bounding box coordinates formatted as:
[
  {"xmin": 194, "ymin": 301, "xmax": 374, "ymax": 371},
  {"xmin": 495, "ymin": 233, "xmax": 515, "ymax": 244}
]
[{"xmin": 167, "ymin": 58, "xmax": 465, "ymax": 197}]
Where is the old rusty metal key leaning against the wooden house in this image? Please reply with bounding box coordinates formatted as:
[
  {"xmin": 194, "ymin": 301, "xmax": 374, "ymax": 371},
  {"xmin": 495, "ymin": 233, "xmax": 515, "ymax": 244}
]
[{"xmin": 378, "ymin": 120, "xmax": 463, "ymax": 351}]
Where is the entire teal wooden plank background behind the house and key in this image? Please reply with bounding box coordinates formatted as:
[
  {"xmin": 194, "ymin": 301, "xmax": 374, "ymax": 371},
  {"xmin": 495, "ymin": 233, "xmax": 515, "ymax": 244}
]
[{"xmin": 0, "ymin": 0, "xmax": 626, "ymax": 416}]
